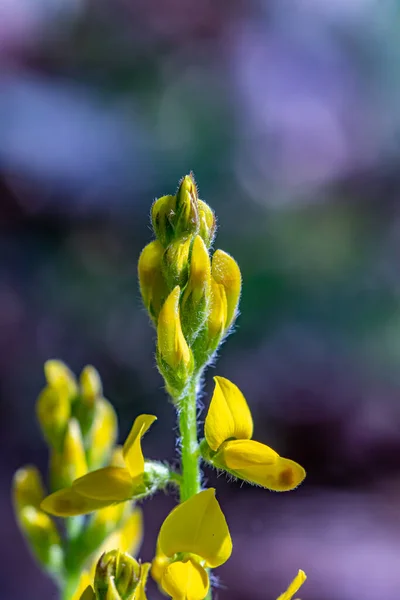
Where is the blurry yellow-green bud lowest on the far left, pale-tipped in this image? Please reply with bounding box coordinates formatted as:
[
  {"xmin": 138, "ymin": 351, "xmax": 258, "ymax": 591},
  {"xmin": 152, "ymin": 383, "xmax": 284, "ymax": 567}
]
[{"xmin": 19, "ymin": 506, "xmax": 62, "ymax": 571}]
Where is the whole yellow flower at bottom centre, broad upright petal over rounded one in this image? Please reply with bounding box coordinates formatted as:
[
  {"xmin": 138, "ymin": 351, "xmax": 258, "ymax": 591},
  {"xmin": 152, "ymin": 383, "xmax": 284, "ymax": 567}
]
[{"xmin": 153, "ymin": 488, "xmax": 232, "ymax": 600}]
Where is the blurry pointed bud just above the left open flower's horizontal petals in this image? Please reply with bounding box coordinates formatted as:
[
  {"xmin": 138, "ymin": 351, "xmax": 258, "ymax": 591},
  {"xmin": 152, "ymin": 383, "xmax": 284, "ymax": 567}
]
[{"xmin": 50, "ymin": 419, "xmax": 88, "ymax": 490}]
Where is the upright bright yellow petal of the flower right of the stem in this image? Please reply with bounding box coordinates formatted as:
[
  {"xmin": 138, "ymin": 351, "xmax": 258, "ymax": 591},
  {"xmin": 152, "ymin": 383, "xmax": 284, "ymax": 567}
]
[{"xmin": 204, "ymin": 377, "xmax": 253, "ymax": 450}]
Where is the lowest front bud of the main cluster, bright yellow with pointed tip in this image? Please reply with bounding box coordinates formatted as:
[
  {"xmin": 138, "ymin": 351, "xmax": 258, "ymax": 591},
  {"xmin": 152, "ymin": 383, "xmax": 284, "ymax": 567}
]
[{"xmin": 157, "ymin": 286, "xmax": 193, "ymax": 391}]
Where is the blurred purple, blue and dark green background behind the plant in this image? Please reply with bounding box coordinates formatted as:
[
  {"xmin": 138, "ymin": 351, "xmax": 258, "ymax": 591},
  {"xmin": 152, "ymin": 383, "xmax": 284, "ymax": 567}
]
[{"xmin": 0, "ymin": 0, "xmax": 400, "ymax": 600}]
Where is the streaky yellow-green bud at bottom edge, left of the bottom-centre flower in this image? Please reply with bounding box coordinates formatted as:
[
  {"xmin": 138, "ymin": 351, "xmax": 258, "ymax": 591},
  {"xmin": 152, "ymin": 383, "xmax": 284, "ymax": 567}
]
[{"xmin": 94, "ymin": 550, "xmax": 140, "ymax": 600}]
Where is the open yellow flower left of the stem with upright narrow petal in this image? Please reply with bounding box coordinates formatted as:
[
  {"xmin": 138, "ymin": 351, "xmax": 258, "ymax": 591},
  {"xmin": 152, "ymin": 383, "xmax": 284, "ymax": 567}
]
[{"xmin": 41, "ymin": 415, "xmax": 157, "ymax": 517}]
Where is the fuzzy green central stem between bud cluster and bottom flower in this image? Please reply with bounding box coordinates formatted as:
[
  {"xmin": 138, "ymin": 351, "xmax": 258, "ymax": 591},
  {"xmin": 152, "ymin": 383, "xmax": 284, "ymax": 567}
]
[{"xmin": 179, "ymin": 378, "xmax": 200, "ymax": 502}]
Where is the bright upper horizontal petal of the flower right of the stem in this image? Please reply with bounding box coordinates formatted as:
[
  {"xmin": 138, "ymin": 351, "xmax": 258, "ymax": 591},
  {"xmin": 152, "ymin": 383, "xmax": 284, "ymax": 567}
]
[{"xmin": 219, "ymin": 440, "xmax": 280, "ymax": 469}]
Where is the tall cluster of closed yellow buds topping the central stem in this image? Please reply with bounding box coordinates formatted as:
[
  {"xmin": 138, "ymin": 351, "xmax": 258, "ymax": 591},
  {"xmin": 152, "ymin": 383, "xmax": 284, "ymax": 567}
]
[{"xmin": 138, "ymin": 174, "xmax": 241, "ymax": 397}]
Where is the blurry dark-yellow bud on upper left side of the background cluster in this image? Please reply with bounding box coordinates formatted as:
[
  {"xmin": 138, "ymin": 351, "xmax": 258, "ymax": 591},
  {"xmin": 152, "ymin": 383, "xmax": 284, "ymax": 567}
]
[{"xmin": 36, "ymin": 386, "xmax": 71, "ymax": 448}]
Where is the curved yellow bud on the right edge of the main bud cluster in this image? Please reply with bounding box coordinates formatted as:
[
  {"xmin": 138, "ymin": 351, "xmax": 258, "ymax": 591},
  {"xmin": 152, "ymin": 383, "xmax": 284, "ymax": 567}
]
[{"xmin": 211, "ymin": 250, "xmax": 242, "ymax": 329}]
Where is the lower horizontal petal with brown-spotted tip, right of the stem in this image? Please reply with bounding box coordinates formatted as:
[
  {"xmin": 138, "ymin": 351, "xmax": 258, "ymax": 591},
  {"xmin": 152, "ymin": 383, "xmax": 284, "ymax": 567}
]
[{"xmin": 225, "ymin": 457, "xmax": 306, "ymax": 492}]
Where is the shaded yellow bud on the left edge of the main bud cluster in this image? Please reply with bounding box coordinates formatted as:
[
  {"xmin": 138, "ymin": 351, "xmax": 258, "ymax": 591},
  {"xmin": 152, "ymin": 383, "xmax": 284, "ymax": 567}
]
[{"xmin": 138, "ymin": 240, "xmax": 168, "ymax": 323}]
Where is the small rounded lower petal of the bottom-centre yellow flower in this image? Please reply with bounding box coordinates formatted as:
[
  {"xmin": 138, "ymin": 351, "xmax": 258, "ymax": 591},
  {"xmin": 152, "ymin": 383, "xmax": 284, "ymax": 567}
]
[{"xmin": 161, "ymin": 559, "xmax": 210, "ymax": 600}]
